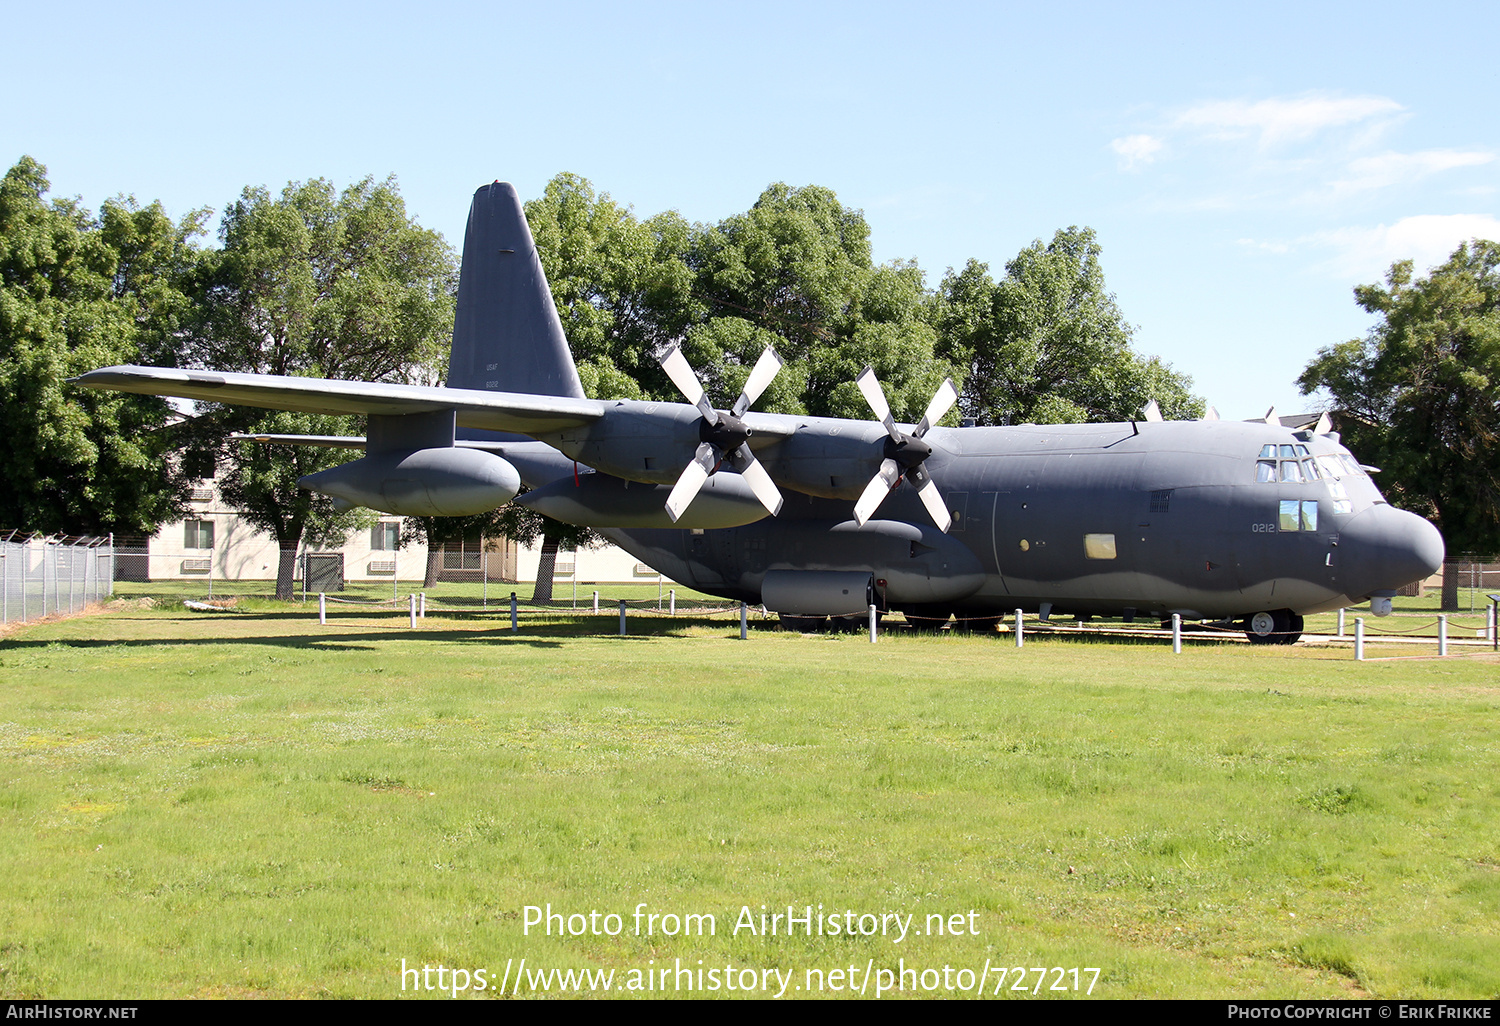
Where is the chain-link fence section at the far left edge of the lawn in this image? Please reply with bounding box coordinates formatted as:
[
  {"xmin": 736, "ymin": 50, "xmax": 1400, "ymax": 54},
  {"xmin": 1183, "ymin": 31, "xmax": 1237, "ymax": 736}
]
[{"xmin": 0, "ymin": 531, "xmax": 114, "ymax": 624}]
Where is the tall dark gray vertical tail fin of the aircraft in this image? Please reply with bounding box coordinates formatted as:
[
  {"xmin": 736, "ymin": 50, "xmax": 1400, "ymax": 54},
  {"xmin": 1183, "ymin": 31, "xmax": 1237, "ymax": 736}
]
[{"xmin": 447, "ymin": 182, "xmax": 584, "ymax": 399}]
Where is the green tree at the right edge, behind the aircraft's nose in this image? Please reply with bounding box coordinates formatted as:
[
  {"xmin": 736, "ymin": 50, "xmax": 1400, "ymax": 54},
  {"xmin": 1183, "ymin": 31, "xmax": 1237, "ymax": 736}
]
[{"xmin": 1298, "ymin": 240, "xmax": 1500, "ymax": 609}]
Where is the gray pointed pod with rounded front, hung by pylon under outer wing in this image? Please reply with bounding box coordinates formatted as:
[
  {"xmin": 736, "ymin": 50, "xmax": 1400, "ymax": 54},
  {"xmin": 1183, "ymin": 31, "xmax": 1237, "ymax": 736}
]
[{"xmin": 297, "ymin": 447, "xmax": 521, "ymax": 516}]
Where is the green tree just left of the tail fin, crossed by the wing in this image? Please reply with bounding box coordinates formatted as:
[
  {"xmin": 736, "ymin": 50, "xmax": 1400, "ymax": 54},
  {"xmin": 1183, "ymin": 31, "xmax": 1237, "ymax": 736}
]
[{"xmin": 188, "ymin": 179, "xmax": 458, "ymax": 599}]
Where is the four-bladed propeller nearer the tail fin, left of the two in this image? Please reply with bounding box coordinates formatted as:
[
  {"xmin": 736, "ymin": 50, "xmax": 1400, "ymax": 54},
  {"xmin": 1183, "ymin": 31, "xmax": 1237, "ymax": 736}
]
[{"xmin": 662, "ymin": 347, "xmax": 782, "ymax": 524}]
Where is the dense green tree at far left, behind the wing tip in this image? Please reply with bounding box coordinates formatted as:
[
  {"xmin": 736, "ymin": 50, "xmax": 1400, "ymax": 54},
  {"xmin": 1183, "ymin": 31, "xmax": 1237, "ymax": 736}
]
[{"xmin": 0, "ymin": 158, "xmax": 207, "ymax": 534}]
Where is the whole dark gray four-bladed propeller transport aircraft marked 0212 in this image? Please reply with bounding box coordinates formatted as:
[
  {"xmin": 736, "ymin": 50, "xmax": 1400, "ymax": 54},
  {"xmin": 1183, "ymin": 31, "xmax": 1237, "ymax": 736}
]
[{"xmin": 75, "ymin": 182, "xmax": 1443, "ymax": 644}]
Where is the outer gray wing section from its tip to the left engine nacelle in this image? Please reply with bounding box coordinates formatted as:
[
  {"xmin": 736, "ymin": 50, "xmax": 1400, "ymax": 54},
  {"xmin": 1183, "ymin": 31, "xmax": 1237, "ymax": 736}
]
[{"xmin": 71, "ymin": 366, "xmax": 606, "ymax": 435}]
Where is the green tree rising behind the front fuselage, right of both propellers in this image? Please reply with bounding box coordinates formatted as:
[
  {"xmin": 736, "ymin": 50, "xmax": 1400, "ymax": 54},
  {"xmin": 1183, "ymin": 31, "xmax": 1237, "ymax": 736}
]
[{"xmin": 936, "ymin": 228, "xmax": 1203, "ymax": 425}]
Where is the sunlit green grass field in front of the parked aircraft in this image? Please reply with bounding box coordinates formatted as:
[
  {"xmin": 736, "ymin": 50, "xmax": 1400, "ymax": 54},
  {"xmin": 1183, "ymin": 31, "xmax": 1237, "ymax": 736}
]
[{"xmin": 0, "ymin": 597, "xmax": 1500, "ymax": 999}]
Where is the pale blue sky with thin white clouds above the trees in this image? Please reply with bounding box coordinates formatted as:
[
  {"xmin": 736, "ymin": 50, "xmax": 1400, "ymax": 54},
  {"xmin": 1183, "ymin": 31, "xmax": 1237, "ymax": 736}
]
[{"xmin": 0, "ymin": 0, "xmax": 1500, "ymax": 417}]
